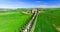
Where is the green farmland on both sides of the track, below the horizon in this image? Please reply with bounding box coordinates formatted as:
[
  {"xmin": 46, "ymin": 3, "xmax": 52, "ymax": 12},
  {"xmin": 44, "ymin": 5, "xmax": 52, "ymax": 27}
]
[{"xmin": 0, "ymin": 8, "xmax": 60, "ymax": 32}]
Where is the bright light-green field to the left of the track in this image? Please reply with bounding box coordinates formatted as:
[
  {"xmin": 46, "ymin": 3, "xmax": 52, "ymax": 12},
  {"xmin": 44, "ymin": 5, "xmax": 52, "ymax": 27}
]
[{"xmin": 0, "ymin": 12, "xmax": 31, "ymax": 32}]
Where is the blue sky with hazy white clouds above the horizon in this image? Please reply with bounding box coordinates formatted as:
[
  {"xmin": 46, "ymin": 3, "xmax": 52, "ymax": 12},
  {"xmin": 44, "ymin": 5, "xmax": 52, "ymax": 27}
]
[{"xmin": 0, "ymin": 0, "xmax": 60, "ymax": 8}]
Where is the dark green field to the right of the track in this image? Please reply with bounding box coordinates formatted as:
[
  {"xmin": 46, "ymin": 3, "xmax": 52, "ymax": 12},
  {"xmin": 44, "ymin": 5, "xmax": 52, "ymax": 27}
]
[{"xmin": 34, "ymin": 9, "xmax": 60, "ymax": 32}]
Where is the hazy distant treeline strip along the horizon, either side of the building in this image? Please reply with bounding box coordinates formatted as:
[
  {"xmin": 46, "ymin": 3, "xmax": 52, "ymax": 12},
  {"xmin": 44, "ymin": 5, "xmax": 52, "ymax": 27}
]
[{"xmin": 0, "ymin": 8, "xmax": 60, "ymax": 12}]
